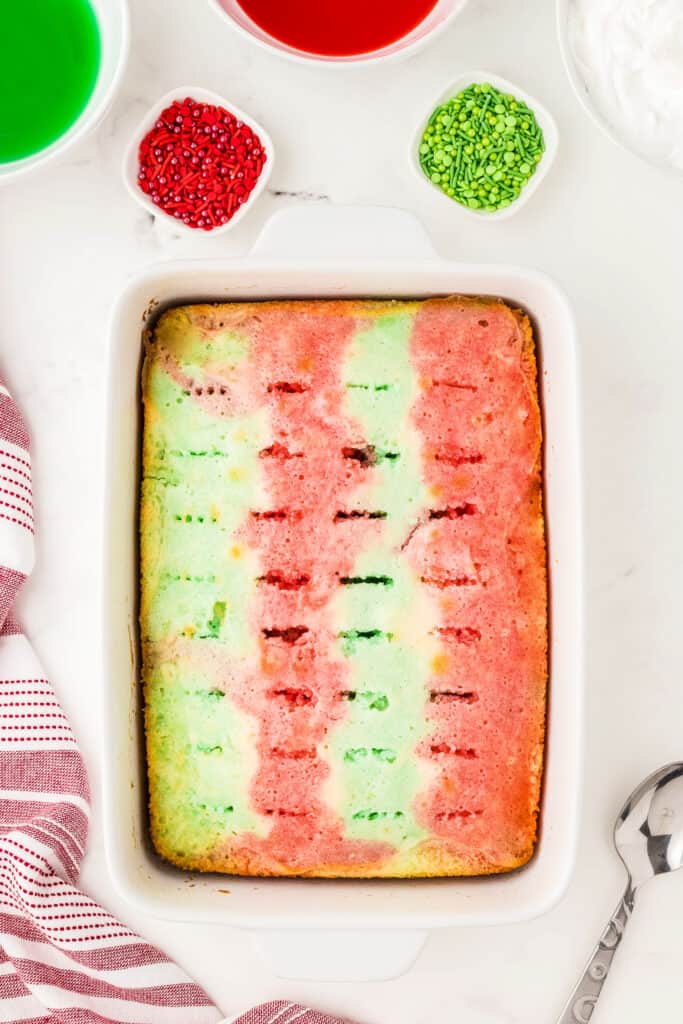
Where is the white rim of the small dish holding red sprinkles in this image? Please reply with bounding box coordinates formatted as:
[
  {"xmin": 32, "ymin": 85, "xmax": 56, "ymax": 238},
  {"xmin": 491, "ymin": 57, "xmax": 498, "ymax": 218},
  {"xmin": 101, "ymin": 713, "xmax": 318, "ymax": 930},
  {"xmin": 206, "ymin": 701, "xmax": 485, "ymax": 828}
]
[{"xmin": 121, "ymin": 85, "xmax": 275, "ymax": 238}]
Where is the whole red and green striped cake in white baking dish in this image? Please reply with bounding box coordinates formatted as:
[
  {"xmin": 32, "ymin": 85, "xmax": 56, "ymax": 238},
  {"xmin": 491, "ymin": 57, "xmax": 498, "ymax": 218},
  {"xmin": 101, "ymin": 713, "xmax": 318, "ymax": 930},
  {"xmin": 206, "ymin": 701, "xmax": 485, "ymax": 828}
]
[{"xmin": 140, "ymin": 297, "xmax": 547, "ymax": 878}]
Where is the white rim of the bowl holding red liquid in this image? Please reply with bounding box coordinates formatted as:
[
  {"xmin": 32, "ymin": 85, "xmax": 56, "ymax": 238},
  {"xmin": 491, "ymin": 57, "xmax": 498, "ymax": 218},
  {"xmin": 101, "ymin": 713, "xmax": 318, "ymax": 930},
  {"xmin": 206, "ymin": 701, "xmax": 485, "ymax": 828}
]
[{"xmin": 208, "ymin": 0, "xmax": 469, "ymax": 69}]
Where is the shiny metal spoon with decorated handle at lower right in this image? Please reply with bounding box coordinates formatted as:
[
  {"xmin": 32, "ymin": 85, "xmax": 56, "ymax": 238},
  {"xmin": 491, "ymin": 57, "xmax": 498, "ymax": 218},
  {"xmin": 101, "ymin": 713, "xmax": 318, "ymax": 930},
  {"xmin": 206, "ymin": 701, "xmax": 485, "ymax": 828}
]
[{"xmin": 558, "ymin": 761, "xmax": 683, "ymax": 1024}]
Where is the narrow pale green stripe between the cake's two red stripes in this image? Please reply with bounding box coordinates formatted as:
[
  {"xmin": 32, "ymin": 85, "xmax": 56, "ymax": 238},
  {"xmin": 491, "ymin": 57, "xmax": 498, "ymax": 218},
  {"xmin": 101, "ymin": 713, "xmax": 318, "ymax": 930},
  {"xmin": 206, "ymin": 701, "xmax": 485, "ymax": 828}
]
[{"xmin": 326, "ymin": 311, "xmax": 436, "ymax": 847}]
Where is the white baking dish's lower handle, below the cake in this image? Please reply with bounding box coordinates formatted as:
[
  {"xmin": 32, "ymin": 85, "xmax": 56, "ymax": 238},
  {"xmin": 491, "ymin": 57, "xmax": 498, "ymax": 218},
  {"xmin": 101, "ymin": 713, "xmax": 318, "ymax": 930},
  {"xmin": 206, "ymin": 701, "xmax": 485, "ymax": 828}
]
[{"xmin": 253, "ymin": 928, "xmax": 428, "ymax": 981}]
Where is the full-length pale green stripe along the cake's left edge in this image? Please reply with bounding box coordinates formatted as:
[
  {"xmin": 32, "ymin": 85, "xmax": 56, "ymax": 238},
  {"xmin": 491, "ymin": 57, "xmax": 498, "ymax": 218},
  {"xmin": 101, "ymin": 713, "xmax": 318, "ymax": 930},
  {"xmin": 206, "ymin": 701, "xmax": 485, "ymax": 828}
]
[{"xmin": 141, "ymin": 324, "xmax": 267, "ymax": 856}]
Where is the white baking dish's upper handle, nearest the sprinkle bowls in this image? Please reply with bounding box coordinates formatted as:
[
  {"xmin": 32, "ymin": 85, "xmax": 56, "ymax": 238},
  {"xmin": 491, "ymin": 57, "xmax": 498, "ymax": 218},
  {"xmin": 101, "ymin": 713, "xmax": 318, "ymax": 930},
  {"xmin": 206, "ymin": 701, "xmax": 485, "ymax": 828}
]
[{"xmin": 252, "ymin": 206, "xmax": 436, "ymax": 263}]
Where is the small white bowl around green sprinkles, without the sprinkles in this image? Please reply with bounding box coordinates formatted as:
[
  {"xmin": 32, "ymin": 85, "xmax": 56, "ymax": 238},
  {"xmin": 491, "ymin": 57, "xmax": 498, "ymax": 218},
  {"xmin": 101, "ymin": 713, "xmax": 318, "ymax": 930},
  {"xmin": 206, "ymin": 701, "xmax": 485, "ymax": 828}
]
[{"xmin": 411, "ymin": 71, "xmax": 559, "ymax": 220}]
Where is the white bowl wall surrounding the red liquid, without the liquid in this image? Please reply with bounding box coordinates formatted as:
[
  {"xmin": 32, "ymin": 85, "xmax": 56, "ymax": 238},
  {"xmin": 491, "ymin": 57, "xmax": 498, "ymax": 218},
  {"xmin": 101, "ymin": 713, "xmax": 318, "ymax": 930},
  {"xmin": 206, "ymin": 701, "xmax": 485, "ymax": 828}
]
[{"xmin": 209, "ymin": 0, "xmax": 467, "ymax": 68}]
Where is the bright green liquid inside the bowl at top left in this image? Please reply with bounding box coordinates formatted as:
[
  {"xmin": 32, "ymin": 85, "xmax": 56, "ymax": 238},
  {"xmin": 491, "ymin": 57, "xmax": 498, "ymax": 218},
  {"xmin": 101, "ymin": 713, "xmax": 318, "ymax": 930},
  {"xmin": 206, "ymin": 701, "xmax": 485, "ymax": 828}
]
[{"xmin": 0, "ymin": 0, "xmax": 99, "ymax": 164}]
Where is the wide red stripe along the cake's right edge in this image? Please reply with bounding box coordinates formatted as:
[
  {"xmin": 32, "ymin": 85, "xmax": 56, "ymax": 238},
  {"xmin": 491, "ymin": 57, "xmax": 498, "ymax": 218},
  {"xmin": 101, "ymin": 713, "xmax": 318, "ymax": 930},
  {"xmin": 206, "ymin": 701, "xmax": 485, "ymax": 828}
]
[{"xmin": 407, "ymin": 304, "xmax": 545, "ymax": 858}]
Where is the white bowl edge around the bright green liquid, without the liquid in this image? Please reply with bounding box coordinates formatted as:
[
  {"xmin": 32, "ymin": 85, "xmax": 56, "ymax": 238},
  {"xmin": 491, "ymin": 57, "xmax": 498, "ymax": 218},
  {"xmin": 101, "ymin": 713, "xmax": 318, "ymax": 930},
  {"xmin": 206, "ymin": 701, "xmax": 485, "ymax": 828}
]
[{"xmin": 0, "ymin": 0, "xmax": 130, "ymax": 184}]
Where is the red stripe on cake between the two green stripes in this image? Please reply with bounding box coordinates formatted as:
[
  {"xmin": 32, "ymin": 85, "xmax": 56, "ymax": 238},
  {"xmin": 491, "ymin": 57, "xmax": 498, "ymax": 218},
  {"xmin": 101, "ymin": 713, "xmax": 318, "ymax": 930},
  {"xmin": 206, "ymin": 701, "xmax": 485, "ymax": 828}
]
[{"xmin": 231, "ymin": 309, "xmax": 394, "ymax": 872}]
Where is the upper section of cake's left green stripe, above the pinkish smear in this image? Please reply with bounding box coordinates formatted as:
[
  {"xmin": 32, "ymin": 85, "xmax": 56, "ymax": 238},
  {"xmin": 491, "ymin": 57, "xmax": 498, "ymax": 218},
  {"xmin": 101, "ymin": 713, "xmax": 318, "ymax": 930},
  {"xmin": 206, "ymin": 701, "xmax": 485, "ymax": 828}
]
[{"xmin": 141, "ymin": 365, "xmax": 267, "ymax": 656}]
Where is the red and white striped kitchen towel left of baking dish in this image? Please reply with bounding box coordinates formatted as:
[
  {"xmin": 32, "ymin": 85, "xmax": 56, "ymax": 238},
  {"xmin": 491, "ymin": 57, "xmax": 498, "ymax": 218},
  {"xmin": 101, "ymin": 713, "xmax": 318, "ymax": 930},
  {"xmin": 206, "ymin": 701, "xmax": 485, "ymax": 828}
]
[{"xmin": 0, "ymin": 382, "xmax": 356, "ymax": 1024}]
